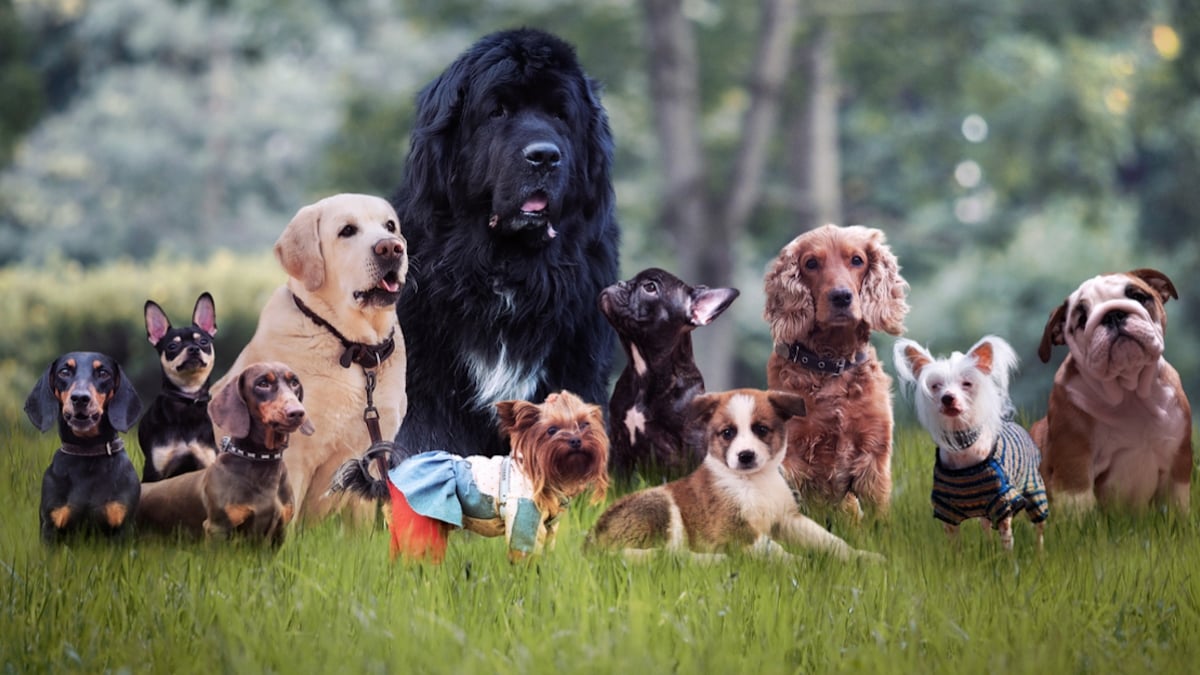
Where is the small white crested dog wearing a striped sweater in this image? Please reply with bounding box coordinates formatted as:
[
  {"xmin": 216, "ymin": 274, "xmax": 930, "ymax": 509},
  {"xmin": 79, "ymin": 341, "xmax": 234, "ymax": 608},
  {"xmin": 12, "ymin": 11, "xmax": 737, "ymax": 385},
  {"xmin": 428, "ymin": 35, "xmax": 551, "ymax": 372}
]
[{"xmin": 894, "ymin": 335, "xmax": 1050, "ymax": 550}]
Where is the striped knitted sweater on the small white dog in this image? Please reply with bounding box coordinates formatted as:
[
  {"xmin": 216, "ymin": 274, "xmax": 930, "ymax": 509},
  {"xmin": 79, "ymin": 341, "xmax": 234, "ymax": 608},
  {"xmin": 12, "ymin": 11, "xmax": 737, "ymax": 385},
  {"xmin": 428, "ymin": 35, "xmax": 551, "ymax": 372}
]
[{"xmin": 931, "ymin": 420, "xmax": 1050, "ymax": 527}]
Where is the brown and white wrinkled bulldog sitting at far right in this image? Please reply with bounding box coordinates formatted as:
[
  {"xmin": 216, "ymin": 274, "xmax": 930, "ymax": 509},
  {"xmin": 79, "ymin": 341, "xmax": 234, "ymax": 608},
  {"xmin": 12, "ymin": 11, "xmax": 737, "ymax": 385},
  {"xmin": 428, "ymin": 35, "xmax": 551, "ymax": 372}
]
[{"xmin": 1031, "ymin": 269, "xmax": 1192, "ymax": 513}]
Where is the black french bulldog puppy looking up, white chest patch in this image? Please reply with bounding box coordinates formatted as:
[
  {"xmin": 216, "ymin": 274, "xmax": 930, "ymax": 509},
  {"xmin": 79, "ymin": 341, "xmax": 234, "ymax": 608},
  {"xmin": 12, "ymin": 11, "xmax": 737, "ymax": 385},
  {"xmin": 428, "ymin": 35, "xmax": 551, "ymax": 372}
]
[{"xmin": 600, "ymin": 268, "xmax": 738, "ymax": 479}]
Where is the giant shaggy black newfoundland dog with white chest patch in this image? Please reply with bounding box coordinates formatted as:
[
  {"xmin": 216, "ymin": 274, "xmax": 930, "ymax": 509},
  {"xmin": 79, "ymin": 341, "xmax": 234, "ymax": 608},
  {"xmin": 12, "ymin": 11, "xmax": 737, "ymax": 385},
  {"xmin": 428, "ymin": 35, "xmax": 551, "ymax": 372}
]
[{"xmin": 392, "ymin": 29, "xmax": 619, "ymax": 455}]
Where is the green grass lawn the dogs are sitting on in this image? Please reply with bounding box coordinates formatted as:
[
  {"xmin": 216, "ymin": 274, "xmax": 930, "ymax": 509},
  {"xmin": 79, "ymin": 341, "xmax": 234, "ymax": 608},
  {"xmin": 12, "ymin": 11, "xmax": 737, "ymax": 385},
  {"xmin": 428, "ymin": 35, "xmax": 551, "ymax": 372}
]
[{"xmin": 0, "ymin": 420, "xmax": 1200, "ymax": 675}]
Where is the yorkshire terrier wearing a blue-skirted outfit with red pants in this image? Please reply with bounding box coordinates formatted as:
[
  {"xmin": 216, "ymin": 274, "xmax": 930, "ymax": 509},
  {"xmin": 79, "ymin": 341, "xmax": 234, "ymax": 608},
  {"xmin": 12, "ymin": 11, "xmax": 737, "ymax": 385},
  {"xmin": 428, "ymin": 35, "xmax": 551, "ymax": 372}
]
[{"xmin": 330, "ymin": 392, "xmax": 608, "ymax": 562}]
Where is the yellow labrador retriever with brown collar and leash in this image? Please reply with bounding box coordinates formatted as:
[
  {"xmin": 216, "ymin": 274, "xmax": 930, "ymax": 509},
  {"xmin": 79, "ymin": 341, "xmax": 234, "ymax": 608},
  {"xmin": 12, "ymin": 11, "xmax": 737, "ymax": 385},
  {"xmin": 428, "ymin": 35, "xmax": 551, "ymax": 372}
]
[{"xmin": 212, "ymin": 195, "xmax": 408, "ymax": 521}]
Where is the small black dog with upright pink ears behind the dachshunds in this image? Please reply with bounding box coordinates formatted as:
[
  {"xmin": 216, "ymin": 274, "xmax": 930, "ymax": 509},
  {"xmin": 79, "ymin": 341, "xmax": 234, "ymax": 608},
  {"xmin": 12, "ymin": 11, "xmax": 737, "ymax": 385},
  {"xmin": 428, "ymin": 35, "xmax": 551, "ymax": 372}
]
[{"xmin": 138, "ymin": 293, "xmax": 217, "ymax": 483}]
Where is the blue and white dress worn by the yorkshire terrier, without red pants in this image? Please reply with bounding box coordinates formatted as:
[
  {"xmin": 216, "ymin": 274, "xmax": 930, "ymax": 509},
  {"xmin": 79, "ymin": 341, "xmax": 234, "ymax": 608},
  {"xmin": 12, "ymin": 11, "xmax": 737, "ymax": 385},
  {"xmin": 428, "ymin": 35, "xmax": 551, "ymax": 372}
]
[{"xmin": 388, "ymin": 450, "xmax": 542, "ymax": 554}]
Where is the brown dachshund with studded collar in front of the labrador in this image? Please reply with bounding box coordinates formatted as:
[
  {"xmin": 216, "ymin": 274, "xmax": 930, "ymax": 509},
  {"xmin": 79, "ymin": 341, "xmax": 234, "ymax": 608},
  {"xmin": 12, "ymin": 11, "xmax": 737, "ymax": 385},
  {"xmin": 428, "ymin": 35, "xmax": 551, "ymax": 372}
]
[{"xmin": 138, "ymin": 363, "xmax": 313, "ymax": 545}]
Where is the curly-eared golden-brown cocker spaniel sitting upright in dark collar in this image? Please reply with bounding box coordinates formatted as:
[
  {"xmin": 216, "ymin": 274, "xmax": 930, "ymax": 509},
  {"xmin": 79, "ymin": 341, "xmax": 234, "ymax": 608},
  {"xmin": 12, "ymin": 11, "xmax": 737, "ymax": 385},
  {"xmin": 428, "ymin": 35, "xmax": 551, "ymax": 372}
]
[{"xmin": 763, "ymin": 225, "xmax": 908, "ymax": 519}]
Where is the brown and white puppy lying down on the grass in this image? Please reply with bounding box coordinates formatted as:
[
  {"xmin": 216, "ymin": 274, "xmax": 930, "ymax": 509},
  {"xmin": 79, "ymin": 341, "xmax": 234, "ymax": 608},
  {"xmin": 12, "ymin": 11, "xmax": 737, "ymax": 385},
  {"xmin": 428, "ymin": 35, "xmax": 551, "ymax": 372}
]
[{"xmin": 587, "ymin": 389, "xmax": 877, "ymax": 560}]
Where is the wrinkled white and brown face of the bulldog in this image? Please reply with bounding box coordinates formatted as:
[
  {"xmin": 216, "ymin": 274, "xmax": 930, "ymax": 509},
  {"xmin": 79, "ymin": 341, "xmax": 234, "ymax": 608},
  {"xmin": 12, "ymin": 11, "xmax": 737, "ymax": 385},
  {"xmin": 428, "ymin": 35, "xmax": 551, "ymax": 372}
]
[{"xmin": 1062, "ymin": 274, "xmax": 1166, "ymax": 380}]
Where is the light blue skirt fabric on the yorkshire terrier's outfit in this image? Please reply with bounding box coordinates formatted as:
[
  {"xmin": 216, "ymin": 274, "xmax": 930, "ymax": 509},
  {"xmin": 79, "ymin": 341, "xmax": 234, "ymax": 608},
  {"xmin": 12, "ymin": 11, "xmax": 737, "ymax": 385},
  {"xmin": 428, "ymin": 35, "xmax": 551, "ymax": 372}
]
[{"xmin": 388, "ymin": 450, "xmax": 500, "ymax": 527}]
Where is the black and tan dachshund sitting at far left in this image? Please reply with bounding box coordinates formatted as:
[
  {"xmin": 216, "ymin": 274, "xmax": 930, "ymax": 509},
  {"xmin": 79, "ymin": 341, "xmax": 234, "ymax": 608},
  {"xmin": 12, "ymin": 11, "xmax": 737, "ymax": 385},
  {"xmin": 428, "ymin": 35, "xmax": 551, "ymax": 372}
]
[{"xmin": 25, "ymin": 352, "xmax": 142, "ymax": 543}]
